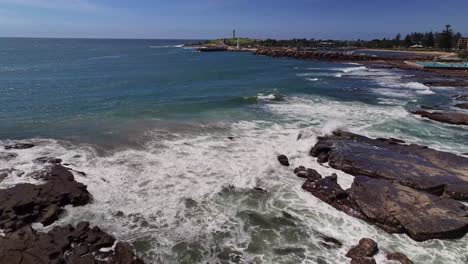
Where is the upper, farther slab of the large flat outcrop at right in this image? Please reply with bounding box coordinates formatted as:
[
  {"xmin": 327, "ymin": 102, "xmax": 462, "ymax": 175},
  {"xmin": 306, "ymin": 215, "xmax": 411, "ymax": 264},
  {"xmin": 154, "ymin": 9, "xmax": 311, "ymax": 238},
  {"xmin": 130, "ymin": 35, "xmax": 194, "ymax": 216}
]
[{"xmin": 311, "ymin": 131, "xmax": 468, "ymax": 200}]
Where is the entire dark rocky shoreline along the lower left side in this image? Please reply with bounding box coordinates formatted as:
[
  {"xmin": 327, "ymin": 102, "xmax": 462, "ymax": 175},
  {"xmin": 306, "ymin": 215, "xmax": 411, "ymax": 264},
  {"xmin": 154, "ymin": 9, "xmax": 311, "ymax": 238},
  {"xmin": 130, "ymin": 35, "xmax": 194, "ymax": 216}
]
[{"xmin": 0, "ymin": 143, "xmax": 143, "ymax": 264}]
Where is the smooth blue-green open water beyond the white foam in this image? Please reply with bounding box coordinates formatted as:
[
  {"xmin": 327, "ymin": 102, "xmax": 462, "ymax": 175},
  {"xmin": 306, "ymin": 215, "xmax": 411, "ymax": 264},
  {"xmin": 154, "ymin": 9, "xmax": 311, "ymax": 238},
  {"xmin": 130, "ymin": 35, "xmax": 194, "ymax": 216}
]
[{"xmin": 0, "ymin": 38, "xmax": 464, "ymax": 146}]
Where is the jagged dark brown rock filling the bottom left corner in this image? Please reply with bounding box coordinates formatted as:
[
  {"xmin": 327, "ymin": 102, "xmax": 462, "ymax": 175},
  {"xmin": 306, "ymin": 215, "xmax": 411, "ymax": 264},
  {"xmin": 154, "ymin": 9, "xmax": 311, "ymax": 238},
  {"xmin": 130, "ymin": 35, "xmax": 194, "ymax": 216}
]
[{"xmin": 0, "ymin": 222, "xmax": 143, "ymax": 264}]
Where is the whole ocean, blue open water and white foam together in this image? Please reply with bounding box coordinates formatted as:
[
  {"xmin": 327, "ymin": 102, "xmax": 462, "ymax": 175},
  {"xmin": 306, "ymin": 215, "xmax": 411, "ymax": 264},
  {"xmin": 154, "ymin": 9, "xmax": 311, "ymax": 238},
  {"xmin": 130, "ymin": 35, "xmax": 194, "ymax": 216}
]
[{"xmin": 0, "ymin": 38, "xmax": 468, "ymax": 263}]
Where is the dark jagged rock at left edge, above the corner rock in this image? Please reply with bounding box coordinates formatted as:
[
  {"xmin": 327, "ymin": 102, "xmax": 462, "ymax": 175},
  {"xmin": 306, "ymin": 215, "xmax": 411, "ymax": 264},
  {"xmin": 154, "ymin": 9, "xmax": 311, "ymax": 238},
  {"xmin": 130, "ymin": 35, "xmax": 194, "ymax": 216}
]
[{"xmin": 0, "ymin": 165, "xmax": 91, "ymax": 233}]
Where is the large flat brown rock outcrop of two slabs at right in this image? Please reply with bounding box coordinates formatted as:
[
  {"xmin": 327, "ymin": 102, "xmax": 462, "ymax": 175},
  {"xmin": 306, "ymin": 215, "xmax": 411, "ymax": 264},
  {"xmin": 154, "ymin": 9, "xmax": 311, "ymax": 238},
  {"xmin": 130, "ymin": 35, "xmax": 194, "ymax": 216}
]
[{"xmin": 288, "ymin": 131, "xmax": 468, "ymax": 241}]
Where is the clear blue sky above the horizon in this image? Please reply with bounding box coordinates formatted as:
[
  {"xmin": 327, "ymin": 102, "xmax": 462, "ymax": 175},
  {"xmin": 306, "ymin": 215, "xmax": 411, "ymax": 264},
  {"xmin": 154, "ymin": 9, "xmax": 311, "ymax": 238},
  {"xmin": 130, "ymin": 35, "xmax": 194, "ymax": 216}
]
[{"xmin": 0, "ymin": 0, "xmax": 468, "ymax": 39}]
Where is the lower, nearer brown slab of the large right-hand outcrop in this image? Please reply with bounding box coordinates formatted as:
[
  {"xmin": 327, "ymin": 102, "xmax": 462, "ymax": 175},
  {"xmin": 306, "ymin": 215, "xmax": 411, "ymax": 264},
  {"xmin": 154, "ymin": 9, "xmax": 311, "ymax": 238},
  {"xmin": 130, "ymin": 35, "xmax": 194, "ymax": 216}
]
[{"xmin": 303, "ymin": 176, "xmax": 468, "ymax": 241}]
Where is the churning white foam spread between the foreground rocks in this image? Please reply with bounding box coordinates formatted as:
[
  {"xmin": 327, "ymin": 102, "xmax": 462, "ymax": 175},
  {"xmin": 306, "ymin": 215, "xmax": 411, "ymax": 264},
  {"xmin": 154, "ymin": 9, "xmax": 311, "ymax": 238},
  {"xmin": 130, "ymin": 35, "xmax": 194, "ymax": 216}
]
[{"xmin": 0, "ymin": 98, "xmax": 468, "ymax": 263}]
